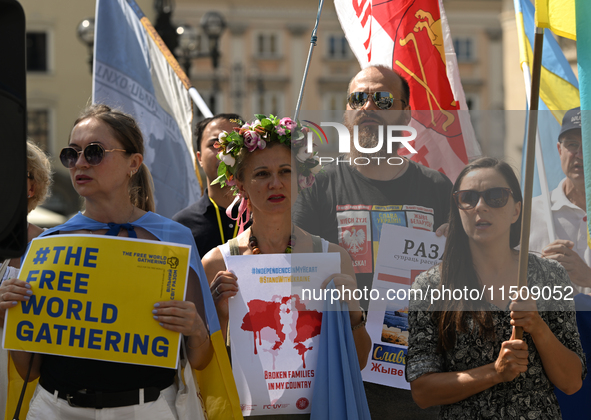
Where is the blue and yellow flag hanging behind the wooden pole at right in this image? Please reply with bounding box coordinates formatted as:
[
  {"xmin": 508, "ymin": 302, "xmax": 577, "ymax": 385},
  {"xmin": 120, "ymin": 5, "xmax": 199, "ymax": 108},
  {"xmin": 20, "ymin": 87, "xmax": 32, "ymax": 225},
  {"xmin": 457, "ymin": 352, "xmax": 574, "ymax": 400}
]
[{"xmin": 514, "ymin": 0, "xmax": 580, "ymax": 197}]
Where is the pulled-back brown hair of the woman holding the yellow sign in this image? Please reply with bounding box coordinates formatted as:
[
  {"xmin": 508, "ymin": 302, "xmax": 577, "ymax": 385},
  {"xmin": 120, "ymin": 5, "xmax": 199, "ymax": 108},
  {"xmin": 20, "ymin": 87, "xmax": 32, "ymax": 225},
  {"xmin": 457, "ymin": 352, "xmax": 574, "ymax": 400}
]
[{"xmin": 74, "ymin": 104, "xmax": 155, "ymax": 211}]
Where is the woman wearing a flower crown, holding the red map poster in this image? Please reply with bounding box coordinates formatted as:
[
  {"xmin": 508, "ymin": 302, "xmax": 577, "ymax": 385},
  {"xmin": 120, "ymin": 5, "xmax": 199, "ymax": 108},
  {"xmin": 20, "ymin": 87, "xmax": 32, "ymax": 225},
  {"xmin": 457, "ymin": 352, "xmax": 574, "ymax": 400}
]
[{"xmin": 203, "ymin": 115, "xmax": 371, "ymax": 414}]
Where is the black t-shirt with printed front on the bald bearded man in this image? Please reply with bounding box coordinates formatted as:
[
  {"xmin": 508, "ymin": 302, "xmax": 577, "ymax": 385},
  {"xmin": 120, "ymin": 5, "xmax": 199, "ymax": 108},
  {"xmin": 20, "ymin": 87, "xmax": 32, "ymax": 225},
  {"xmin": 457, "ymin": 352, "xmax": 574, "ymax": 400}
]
[{"xmin": 293, "ymin": 159, "xmax": 453, "ymax": 420}]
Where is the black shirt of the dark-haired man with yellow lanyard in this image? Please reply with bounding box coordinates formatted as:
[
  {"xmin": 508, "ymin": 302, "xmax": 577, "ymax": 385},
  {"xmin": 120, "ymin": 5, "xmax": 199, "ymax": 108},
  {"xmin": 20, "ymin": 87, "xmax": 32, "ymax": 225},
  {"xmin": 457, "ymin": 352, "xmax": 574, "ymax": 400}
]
[{"xmin": 172, "ymin": 190, "xmax": 248, "ymax": 258}]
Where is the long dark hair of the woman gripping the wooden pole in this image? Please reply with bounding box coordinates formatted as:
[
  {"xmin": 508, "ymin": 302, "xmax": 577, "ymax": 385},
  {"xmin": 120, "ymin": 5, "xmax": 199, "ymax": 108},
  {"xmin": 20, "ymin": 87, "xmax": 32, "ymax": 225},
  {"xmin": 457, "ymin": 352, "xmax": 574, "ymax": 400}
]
[{"xmin": 433, "ymin": 158, "xmax": 522, "ymax": 352}]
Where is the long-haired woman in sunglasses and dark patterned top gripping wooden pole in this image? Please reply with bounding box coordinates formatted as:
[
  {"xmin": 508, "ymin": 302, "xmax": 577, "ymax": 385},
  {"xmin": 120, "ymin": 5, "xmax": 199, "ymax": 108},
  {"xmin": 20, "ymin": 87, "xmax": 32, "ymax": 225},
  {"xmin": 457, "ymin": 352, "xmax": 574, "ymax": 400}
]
[{"xmin": 406, "ymin": 158, "xmax": 587, "ymax": 419}]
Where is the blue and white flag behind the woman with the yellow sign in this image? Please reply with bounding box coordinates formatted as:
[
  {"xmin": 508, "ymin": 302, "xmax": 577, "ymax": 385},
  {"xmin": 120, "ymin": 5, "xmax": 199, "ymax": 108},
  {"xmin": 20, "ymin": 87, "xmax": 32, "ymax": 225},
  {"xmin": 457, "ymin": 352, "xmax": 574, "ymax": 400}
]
[{"xmin": 93, "ymin": 0, "xmax": 201, "ymax": 217}]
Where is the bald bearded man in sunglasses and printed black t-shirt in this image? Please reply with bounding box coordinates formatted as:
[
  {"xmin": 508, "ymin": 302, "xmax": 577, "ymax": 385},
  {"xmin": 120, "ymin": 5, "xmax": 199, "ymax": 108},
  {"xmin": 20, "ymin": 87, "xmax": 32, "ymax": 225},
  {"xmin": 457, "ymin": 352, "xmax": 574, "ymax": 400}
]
[{"xmin": 293, "ymin": 66, "xmax": 452, "ymax": 420}]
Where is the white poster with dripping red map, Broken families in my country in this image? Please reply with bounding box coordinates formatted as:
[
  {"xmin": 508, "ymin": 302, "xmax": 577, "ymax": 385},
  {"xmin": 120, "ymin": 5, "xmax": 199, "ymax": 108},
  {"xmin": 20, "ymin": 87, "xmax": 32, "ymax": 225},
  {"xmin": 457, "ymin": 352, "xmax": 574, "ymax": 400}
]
[{"xmin": 226, "ymin": 253, "xmax": 341, "ymax": 416}]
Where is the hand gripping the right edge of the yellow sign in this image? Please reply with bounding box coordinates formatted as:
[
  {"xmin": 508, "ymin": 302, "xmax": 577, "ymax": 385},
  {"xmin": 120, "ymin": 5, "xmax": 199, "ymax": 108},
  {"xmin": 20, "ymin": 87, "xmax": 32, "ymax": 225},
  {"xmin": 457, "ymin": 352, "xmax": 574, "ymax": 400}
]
[{"xmin": 152, "ymin": 300, "xmax": 205, "ymax": 337}]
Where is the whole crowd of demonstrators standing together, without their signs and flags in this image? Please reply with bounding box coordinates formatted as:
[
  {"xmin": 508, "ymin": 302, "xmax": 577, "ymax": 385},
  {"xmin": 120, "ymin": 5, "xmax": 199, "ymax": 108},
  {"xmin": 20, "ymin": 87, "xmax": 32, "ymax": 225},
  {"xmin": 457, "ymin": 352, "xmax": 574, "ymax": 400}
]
[{"xmin": 0, "ymin": 66, "xmax": 591, "ymax": 419}]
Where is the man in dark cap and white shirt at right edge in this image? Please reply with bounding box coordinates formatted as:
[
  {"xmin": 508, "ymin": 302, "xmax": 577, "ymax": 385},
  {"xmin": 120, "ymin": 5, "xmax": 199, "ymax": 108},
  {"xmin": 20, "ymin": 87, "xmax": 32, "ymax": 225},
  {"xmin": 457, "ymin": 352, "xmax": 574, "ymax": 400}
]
[{"xmin": 529, "ymin": 108, "xmax": 591, "ymax": 293}]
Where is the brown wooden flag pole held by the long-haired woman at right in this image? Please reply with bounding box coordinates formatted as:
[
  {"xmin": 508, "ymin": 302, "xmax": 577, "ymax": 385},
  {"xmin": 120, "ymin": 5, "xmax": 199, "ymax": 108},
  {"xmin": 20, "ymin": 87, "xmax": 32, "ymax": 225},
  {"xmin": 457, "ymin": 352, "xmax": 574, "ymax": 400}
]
[{"xmin": 515, "ymin": 27, "xmax": 544, "ymax": 339}]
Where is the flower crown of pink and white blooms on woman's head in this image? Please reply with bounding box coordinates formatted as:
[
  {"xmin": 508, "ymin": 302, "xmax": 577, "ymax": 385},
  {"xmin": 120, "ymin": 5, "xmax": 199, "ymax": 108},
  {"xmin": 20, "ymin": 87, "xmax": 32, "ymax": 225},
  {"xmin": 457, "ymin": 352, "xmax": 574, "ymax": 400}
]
[{"xmin": 212, "ymin": 114, "xmax": 322, "ymax": 195}]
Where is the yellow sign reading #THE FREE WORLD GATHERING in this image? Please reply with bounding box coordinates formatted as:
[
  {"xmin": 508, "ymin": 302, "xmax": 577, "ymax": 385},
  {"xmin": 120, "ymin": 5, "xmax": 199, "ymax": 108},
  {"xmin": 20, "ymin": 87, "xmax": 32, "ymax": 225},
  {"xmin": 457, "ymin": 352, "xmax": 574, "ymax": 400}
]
[{"xmin": 3, "ymin": 235, "xmax": 191, "ymax": 368}]
